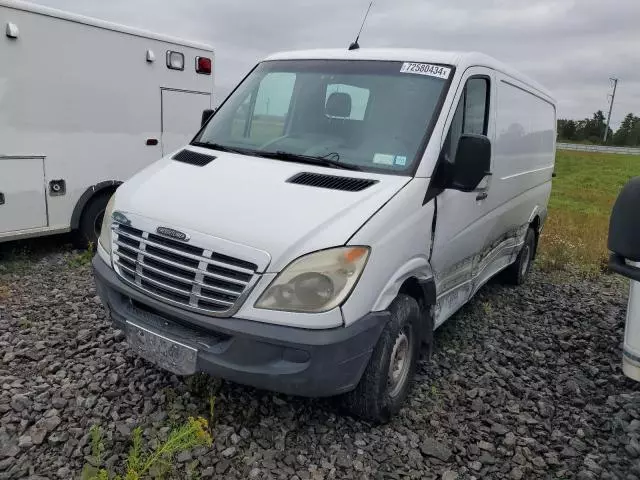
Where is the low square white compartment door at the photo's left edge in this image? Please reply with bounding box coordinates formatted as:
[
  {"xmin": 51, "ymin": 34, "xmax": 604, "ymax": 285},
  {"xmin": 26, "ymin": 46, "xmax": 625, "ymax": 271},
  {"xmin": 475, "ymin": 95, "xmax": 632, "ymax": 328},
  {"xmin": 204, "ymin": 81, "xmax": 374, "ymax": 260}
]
[{"xmin": 0, "ymin": 156, "xmax": 47, "ymax": 233}]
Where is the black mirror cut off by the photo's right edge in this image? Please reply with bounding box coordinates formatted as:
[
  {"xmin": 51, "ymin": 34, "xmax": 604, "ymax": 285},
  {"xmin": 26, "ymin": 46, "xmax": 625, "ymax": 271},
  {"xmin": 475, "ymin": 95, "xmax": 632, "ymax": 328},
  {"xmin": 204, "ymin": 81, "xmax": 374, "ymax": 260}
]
[{"xmin": 608, "ymin": 177, "xmax": 640, "ymax": 281}]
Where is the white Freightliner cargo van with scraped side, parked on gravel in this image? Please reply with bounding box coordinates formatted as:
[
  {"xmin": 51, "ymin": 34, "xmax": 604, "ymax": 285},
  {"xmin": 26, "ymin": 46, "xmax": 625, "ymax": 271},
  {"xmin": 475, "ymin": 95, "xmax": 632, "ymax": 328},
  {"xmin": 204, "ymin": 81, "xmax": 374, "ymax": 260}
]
[{"xmin": 94, "ymin": 49, "xmax": 556, "ymax": 421}]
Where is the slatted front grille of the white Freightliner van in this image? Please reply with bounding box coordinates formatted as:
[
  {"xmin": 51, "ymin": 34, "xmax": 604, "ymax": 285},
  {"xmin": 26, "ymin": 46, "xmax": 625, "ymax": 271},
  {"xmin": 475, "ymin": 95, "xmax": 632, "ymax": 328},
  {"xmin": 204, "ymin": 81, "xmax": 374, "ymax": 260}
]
[{"xmin": 113, "ymin": 223, "xmax": 258, "ymax": 316}]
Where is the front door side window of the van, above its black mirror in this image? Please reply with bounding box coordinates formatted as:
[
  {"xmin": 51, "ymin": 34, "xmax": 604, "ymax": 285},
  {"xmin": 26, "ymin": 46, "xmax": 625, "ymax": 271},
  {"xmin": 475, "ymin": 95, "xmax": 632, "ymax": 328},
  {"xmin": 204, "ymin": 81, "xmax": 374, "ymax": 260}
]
[{"xmin": 445, "ymin": 77, "xmax": 489, "ymax": 162}]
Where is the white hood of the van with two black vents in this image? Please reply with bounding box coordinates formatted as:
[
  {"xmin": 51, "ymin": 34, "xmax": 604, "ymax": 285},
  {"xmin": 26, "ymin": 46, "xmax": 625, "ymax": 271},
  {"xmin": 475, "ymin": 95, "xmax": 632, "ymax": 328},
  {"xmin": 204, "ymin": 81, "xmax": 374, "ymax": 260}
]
[{"xmin": 114, "ymin": 147, "xmax": 410, "ymax": 272}]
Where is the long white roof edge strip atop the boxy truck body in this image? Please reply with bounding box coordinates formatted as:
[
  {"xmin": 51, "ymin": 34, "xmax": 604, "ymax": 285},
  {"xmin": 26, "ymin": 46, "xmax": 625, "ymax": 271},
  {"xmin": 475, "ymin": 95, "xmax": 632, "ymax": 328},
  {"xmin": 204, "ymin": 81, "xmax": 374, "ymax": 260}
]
[{"xmin": 0, "ymin": 0, "xmax": 213, "ymax": 52}]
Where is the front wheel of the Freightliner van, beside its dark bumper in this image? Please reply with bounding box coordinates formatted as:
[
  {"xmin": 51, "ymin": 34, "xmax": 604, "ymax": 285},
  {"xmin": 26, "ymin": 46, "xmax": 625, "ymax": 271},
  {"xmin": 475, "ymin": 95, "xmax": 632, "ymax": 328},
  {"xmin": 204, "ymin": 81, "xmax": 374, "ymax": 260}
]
[{"xmin": 342, "ymin": 294, "xmax": 420, "ymax": 423}]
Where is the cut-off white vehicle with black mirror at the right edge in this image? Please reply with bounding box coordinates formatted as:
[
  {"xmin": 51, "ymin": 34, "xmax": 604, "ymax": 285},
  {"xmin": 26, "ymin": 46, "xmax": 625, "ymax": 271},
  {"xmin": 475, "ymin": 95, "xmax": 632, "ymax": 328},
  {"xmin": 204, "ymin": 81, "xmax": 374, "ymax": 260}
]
[{"xmin": 609, "ymin": 177, "xmax": 640, "ymax": 382}]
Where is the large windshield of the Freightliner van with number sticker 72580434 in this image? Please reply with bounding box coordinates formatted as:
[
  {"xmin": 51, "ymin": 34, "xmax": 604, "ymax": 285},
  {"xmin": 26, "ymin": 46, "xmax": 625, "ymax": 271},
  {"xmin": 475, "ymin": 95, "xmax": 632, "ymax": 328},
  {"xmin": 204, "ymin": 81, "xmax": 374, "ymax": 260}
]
[{"xmin": 193, "ymin": 60, "xmax": 451, "ymax": 175}]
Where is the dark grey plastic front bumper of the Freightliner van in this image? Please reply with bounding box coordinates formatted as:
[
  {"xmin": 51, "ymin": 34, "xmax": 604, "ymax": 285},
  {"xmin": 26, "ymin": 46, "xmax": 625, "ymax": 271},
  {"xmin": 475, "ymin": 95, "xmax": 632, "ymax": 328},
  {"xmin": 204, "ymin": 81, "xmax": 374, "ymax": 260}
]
[{"xmin": 93, "ymin": 256, "xmax": 389, "ymax": 397}]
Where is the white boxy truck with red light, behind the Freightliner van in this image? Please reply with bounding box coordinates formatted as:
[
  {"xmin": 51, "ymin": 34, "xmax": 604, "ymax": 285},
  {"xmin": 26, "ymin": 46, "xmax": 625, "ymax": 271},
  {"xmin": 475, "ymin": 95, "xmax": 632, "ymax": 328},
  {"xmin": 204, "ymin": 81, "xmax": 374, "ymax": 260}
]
[{"xmin": 0, "ymin": 0, "xmax": 213, "ymax": 246}]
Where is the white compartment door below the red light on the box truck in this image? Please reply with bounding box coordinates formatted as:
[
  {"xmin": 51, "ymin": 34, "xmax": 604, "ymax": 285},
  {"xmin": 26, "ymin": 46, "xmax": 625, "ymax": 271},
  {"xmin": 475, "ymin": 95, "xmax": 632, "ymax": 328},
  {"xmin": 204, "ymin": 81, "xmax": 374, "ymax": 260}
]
[{"xmin": 162, "ymin": 88, "xmax": 211, "ymax": 156}]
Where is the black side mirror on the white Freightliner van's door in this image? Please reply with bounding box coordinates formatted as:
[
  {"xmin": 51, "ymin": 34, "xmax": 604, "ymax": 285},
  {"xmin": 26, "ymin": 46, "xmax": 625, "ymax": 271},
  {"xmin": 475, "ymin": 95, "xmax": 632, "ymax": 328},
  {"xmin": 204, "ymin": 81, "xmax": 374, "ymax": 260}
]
[{"xmin": 449, "ymin": 133, "xmax": 491, "ymax": 192}]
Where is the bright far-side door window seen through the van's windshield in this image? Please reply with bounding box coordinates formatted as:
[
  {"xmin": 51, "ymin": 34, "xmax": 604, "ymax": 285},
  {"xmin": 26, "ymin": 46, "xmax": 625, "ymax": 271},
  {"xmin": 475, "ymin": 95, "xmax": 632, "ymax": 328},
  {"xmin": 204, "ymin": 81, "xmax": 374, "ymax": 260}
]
[{"xmin": 231, "ymin": 72, "xmax": 296, "ymax": 146}]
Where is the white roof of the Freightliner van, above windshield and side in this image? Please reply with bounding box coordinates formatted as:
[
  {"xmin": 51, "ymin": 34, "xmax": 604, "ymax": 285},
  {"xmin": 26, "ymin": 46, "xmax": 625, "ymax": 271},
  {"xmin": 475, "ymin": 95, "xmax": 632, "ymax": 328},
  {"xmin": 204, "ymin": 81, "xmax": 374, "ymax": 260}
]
[{"xmin": 265, "ymin": 48, "xmax": 553, "ymax": 99}]
